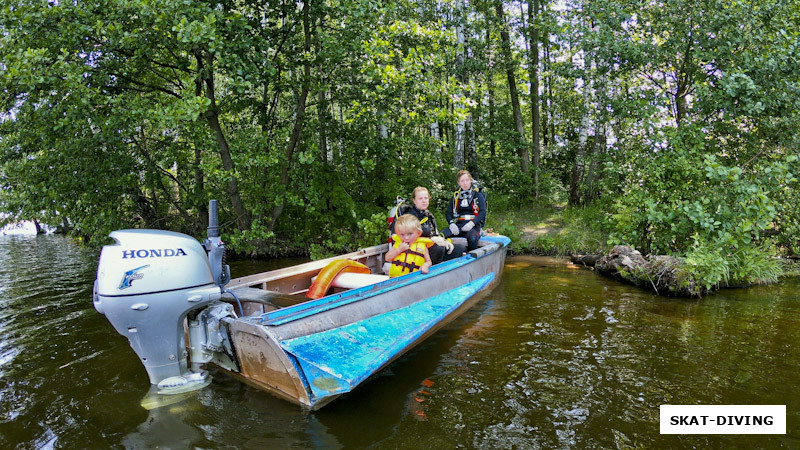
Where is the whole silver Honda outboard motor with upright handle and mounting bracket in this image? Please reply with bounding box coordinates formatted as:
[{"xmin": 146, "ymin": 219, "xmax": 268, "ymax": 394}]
[{"xmin": 93, "ymin": 200, "xmax": 235, "ymax": 391}]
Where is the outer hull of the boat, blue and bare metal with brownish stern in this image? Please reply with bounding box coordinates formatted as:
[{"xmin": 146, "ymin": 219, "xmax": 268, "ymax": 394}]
[{"xmin": 220, "ymin": 236, "xmax": 509, "ymax": 410}]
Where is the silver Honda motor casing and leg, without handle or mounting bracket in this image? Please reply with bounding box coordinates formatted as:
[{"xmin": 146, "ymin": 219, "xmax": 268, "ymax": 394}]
[{"xmin": 93, "ymin": 230, "xmax": 221, "ymax": 384}]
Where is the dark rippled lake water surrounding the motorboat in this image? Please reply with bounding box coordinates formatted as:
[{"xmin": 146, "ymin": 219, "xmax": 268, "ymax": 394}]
[{"xmin": 0, "ymin": 236, "xmax": 800, "ymax": 449}]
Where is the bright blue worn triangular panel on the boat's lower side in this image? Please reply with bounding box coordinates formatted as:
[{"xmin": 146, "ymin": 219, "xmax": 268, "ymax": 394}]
[{"xmin": 281, "ymin": 273, "xmax": 495, "ymax": 403}]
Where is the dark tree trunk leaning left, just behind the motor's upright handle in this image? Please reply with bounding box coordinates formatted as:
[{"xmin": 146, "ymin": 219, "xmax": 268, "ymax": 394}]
[{"xmin": 195, "ymin": 50, "xmax": 251, "ymax": 230}]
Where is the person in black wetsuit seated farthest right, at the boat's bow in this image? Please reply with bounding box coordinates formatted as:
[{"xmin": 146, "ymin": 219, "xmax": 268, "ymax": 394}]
[{"xmin": 443, "ymin": 170, "xmax": 486, "ymax": 251}]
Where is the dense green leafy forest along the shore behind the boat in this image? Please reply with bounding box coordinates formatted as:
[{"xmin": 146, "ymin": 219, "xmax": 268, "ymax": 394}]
[{"xmin": 0, "ymin": 0, "xmax": 800, "ymax": 270}]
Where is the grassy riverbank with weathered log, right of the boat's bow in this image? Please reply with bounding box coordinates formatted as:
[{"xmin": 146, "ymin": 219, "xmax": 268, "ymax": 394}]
[{"xmin": 494, "ymin": 206, "xmax": 800, "ymax": 297}]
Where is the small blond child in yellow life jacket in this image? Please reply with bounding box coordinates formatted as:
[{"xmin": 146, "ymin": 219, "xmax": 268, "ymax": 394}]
[{"xmin": 385, "ymin": 214, "xmax": 433, "ymax": 277}]
